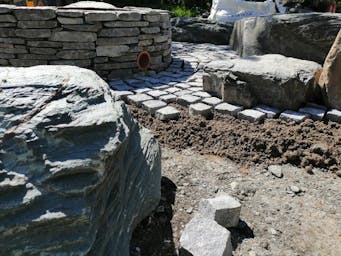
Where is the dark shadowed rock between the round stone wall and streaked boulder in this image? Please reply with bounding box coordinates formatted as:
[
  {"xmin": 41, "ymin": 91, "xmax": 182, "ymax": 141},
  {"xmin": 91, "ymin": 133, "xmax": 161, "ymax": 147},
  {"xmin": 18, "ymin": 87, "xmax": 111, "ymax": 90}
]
[{"xmin": 171, "ymin": 17, "xmax": 233, "ymax": 45}]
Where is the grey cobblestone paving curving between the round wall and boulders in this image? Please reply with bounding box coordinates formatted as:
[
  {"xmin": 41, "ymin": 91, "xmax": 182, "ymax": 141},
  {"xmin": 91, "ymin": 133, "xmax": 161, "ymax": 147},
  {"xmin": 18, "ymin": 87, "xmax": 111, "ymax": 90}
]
[{"xmin": 109, "ymin": 42, "xmax": 341, "ymax": 123}]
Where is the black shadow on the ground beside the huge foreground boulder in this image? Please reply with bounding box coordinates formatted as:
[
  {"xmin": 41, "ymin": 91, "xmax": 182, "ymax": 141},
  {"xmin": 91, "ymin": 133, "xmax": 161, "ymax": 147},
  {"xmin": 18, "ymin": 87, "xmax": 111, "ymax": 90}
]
[{"xmin": 130, "ymin": 177, "xmax": 177, "ymax": 256}]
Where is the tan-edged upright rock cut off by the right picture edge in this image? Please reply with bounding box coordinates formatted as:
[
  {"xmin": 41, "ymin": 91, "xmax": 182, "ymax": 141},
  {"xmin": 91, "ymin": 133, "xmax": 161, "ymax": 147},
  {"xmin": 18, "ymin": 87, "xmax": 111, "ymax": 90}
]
[{"xmin": 318, "ymin": 30, "xmax": 341, "ymax": 110}]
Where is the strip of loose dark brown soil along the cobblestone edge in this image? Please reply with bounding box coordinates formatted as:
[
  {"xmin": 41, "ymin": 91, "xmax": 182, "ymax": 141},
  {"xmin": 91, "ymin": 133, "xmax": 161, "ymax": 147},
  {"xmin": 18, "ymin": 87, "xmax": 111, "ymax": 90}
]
[{"xmin": 130, "ymin": 105, "xmax": 341, "ymax": 172}]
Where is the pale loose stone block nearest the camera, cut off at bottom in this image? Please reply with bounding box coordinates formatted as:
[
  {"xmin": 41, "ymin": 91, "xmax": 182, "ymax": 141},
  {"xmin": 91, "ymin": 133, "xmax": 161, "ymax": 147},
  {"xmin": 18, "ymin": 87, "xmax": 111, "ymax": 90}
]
[{"xmin": 179, "ymin": 217, "xmax": 232, "ymax": 256}]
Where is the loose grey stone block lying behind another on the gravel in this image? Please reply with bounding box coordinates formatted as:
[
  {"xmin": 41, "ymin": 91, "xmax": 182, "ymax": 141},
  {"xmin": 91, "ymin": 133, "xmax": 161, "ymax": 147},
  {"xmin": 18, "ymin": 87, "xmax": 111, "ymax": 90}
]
[{"xmin": 198, "ymin": 194, "xmax": 241, "ymax": 228}]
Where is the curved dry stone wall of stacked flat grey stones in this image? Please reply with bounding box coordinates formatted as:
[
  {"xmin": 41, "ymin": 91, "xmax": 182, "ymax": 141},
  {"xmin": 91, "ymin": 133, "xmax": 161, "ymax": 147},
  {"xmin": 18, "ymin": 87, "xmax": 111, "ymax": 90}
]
[{"xmin": 0, "ymin": 5, "xmax": 171, "ymax": 79}]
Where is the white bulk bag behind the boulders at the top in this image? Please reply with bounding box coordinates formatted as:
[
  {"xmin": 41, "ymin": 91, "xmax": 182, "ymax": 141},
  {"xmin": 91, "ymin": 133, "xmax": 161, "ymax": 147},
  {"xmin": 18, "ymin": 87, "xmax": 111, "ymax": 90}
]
[{"xmin": 208, "ymin": 0, "xmax": 285, "ymax": 23}]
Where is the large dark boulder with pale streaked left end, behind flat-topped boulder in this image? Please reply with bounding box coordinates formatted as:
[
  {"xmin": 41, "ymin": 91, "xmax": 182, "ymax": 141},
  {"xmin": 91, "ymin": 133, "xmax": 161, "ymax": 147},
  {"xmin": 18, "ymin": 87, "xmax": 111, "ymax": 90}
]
[{"xmin": 230, "ymin": 13, "xmax": 341, "ymax": 64}]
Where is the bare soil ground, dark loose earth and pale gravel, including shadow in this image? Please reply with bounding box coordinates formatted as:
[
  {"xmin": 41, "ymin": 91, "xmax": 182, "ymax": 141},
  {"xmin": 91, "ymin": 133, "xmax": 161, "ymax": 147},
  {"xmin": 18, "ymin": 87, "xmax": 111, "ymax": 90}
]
[{"xmin": 130, "ymin": 105, "xmax": 341, "ymax": 256}]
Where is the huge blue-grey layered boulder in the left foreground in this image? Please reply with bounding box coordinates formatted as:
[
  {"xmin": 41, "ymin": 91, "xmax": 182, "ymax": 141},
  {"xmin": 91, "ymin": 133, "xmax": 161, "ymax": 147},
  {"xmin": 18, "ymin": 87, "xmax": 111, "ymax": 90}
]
[{"xmin": 0, "ymin": 66, "xmax": 161, "ymax": 256}]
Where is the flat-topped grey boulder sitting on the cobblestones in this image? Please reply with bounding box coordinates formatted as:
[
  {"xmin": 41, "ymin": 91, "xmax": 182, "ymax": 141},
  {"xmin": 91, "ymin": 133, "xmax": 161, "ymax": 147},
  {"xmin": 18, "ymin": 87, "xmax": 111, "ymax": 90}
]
[{"xmin": 203, "ymin": 54, "xmax": 321, "ymax": 110}]
